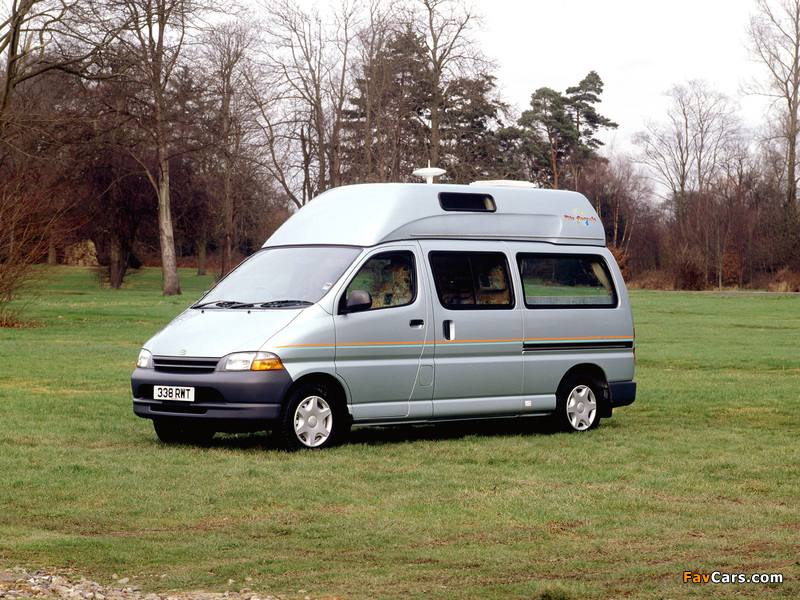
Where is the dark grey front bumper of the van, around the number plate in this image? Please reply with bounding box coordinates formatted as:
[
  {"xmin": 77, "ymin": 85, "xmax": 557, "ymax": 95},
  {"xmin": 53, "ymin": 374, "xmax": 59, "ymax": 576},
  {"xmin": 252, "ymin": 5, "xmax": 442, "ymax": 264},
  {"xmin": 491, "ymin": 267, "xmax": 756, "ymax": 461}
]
[{"xmin": 131, "ymin": 368, "xmax": 292, "ymax": 430}]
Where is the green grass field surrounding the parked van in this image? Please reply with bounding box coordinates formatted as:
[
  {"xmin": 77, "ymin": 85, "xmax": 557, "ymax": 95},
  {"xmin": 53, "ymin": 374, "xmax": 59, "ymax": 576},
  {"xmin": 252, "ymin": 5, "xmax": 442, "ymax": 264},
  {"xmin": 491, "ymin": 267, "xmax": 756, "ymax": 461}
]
[{"xmin": 0, "ymin": 269, "xmax": 800, "ymax": 600}]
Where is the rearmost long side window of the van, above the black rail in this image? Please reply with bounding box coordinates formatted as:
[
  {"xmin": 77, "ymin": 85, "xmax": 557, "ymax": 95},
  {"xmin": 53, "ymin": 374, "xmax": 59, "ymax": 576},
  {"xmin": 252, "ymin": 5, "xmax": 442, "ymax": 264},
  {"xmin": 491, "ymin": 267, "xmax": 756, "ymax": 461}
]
[{"xmin": 517, "ymin": 254, "xmax": 617, "ymax": 308}]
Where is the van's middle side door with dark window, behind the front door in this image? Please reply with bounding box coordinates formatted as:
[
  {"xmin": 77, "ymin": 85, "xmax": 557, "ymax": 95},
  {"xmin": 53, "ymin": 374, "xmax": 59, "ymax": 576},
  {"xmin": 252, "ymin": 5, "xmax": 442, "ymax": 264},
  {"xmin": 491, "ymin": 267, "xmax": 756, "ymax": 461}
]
[{"xmin": 421, "ymin": 240, "xmax": 523, "ymax": 419}]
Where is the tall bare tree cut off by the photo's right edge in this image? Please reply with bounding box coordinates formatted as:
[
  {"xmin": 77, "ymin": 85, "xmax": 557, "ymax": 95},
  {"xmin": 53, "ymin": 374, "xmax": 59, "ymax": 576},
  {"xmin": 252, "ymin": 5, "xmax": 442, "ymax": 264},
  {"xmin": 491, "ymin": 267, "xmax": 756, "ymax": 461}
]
[{"xmin": 747, "ymin": 0, "xmax": 800, "ymax": 218}]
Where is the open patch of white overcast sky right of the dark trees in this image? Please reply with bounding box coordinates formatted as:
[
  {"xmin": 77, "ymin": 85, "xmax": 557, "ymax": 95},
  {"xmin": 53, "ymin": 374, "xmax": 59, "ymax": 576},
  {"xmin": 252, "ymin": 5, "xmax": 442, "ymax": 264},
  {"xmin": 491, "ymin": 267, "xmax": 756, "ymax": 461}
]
[{"xmin": 475, "ymin": 0, "xmax": 765, "ymax": 150}]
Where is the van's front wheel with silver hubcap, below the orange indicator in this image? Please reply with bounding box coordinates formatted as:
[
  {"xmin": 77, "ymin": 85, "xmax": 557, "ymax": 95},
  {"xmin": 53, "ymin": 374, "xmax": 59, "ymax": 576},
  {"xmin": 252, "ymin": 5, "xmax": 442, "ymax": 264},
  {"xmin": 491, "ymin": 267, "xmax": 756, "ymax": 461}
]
[{"xmin": 281, "ymin": 383, "xmax": 350, "ymax": 450}]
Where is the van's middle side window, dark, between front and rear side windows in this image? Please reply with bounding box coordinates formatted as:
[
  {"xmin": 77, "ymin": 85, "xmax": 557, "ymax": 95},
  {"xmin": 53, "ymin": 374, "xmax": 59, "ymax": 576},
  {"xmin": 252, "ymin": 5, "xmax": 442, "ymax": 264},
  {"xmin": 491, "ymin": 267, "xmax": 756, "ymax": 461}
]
[{"xmin": 430, "ymin": 252, "xmax": 514, "ymax": 309}]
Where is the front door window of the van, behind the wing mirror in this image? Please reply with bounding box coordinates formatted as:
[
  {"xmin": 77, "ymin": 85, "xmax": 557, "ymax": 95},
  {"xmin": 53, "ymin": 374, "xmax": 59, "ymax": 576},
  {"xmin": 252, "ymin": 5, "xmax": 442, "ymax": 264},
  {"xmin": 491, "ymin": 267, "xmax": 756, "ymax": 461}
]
[{"xmin": 342, "ymin": 252, "xmax": 416, "ymax": 310}]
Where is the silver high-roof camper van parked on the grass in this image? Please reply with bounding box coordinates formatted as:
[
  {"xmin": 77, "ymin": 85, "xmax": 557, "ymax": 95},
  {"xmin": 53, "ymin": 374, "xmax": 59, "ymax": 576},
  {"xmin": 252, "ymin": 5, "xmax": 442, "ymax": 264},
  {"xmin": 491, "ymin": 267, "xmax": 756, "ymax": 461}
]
[{"xmin": 131, "ymin": 182, "xmax": 636, "ymax": 449}]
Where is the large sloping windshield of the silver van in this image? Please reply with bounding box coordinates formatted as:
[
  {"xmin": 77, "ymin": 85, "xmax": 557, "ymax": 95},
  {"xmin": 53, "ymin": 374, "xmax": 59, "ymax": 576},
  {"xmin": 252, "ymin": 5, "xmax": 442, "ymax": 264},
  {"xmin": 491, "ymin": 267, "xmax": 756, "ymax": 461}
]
[{"xmin": 197, "ymin": 246, "xmax": 361, "ymax": 308}]
